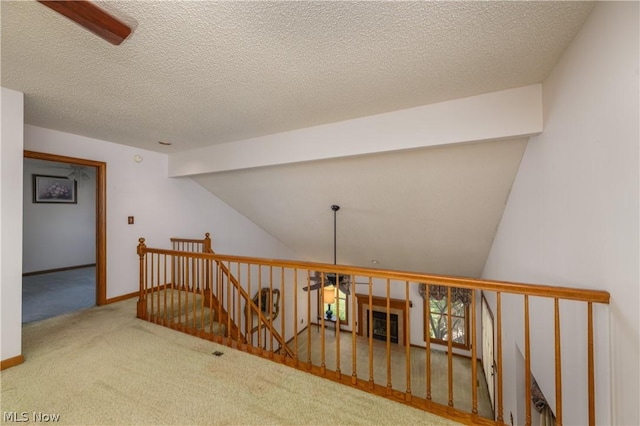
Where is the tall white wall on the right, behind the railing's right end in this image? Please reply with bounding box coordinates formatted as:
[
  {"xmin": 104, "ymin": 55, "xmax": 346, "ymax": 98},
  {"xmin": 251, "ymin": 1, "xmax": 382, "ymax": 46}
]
[{"xmin": 483, "ymin": 2, "xmax": 640, "ymax": 425}]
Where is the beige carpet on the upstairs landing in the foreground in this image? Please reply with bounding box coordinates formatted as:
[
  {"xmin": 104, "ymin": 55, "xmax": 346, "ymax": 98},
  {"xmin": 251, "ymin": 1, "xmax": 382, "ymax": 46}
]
[{"xmin": 0, "ymin": 300, "xmax": 457, "ymax": 425}]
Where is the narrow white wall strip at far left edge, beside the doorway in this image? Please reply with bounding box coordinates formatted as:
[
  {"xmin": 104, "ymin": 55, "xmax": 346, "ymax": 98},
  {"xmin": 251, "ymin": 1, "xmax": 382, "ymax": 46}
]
[{"xmin": 0, "ymin": 88, "xmax": 24, "ymax": 360}]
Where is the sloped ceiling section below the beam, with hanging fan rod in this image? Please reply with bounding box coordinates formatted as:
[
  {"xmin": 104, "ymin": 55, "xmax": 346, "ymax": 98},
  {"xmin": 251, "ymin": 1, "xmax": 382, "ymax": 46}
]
[{"xmin": 194, "ymin": 138, "xmax": 527, "ymax": 277}]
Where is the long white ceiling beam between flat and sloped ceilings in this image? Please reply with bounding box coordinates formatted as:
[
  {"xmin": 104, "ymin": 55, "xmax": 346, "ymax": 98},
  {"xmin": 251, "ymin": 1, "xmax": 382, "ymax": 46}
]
[{"xmin": 169, "ymin": 84, "xmax": 543, "ymax": 177}]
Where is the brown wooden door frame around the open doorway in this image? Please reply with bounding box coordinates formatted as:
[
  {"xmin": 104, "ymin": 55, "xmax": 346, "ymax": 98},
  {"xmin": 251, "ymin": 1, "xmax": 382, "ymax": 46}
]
[{"xmin": 24, "ymin": 151, "xmax": 107, "ymax": 305}]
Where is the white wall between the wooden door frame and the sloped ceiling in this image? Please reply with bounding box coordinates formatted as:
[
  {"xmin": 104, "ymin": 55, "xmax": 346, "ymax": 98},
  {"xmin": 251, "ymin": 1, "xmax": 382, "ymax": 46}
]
[{"xmin": 24, "ymin": 126, "xmax": 294, "ymax": 298}]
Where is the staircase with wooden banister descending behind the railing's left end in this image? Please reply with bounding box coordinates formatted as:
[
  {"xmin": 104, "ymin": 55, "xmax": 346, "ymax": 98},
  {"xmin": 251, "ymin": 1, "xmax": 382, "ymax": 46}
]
[{"xmin": 137, "ymin": 233, "xmax": 293, "ymax": 358}]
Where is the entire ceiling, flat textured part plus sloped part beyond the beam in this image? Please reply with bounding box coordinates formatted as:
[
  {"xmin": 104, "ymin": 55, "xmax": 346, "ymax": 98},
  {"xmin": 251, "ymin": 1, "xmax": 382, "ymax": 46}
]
[{"xmin": 0, "ymin": 0, "xmax": 593, "ymax": 276}]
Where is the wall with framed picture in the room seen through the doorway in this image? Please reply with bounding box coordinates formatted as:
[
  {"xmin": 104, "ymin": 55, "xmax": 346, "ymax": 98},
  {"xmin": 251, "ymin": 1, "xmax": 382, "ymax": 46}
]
[{"xmin": 22, "ymin": 159, "xmax": 96, "ymax": 273}]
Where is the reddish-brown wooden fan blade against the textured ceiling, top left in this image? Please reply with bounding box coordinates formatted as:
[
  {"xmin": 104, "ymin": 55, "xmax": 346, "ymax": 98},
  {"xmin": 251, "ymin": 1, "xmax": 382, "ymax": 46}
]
[{"xmin": 38, "ymin": 0, "xmax": 131, "ymax": 46}]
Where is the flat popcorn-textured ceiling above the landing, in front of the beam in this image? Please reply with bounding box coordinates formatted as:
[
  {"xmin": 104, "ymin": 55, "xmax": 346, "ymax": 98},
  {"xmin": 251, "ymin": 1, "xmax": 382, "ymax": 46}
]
[{"xmin": 1, "ymin": 1, "xmax": 593, "ymax": 152}]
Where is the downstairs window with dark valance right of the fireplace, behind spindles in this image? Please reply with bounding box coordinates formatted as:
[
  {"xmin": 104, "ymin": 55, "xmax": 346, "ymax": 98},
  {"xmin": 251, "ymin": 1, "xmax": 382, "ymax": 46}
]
[{"xmin": 421, "ymin": 285, "xmax": 470, "ymax": 349}]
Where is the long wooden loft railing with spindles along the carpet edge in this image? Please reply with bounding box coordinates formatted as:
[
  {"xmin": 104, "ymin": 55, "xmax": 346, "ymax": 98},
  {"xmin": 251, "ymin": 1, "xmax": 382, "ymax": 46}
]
[{"xmin": 138, "ymin": 234, "xmax": 609, "ymax": 424}]
